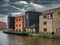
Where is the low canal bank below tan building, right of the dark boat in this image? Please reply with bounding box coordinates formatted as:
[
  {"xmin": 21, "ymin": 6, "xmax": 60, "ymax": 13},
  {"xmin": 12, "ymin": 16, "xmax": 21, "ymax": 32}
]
[{"xmin": 29, "ymin": 33, "xmax": 60, "ymax": 39}]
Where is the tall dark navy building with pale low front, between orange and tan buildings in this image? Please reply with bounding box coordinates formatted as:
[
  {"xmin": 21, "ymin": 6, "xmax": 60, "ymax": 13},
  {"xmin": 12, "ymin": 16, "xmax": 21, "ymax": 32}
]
[{"xmin": 25, "ymin": 11, "xmax": 41, "ymax": 32}]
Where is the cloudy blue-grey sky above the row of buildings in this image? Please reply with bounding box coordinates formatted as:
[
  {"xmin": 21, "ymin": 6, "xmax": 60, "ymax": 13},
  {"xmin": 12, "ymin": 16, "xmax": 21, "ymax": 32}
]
[{"xmin": 0, "ymin": 0, "xmax": 60, "ymax": 22}]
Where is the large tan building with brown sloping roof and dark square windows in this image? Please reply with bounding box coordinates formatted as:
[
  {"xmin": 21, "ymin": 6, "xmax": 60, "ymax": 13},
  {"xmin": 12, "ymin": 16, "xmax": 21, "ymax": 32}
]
[{"xmin": 39, "ymin": 8, "xmax": 60, "ymax": 33}]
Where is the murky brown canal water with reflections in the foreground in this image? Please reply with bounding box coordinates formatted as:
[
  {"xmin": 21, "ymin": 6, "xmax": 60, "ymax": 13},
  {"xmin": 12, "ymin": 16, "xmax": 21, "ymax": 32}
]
[{"xmin": 0, "ymin": 31, "xmax": 60, "ymax": 45}]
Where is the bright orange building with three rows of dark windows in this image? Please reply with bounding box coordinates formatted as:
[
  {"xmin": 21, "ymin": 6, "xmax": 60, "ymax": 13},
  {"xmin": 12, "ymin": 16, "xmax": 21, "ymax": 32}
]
[{"xmin": 15, "ymin": 15, "xmax": 25, "ymax": 32}]
